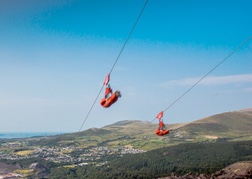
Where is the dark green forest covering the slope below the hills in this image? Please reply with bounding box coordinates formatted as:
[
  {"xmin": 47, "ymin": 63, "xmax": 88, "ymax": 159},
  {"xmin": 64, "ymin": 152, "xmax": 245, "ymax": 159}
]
[{"xmin": 50, "ymin": 141, "xmax": 252, "ymax": 179}]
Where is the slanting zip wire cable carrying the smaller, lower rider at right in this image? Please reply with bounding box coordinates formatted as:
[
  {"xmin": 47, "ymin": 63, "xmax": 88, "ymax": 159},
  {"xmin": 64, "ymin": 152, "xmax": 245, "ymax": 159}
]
[{"xmin": 151, "ymin": 36, "xmax": 252, "ymax": 122}]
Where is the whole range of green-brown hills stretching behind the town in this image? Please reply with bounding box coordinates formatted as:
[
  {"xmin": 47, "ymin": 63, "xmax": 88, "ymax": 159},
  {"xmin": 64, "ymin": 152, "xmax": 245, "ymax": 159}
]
[{"xmin": 29, "ymin": 109, "xmax": 252, "ymax": 150}]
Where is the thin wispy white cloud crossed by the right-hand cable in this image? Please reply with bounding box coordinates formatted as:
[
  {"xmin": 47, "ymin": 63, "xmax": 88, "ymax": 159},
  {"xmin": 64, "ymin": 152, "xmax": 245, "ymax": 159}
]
[{"xmin": 160, "ymin": 74, "xmax": 252, "ymax": 88}]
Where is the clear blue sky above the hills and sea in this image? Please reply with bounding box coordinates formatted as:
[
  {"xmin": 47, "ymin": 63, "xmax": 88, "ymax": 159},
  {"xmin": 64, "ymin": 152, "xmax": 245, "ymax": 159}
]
[{"xmin": 0, "ymin": 0, "xmax": 252, "ymax": 132}]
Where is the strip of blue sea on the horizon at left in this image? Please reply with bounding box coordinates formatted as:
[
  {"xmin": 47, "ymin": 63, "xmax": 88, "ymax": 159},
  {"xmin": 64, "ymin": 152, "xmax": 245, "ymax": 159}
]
[{"xmin": 0, "ymin": 132, "xmax": 67, "ymax": 139}]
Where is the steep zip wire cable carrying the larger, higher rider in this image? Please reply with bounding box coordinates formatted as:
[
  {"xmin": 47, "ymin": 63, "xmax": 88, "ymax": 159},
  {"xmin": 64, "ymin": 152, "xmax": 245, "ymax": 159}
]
[{"xmin": 79, "ymin": 0, "xmax": 148, "ymax": 132}]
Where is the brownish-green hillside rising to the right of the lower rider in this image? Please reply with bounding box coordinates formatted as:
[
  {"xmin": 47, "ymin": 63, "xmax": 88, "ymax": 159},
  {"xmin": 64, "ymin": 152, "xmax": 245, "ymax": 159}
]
[{"xmin": 172, "ymin": 109, "xmax": 252, "ymax": 140}]
